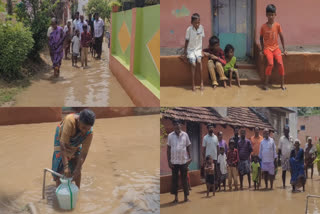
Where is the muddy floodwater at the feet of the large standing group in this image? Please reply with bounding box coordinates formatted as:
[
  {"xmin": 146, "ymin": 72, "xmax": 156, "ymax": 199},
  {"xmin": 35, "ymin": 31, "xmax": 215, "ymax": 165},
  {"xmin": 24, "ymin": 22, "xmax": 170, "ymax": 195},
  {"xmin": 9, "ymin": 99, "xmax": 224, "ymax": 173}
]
[{"xmin": 160, "ymin": 171, "xmax": 320, "ymax": 214}]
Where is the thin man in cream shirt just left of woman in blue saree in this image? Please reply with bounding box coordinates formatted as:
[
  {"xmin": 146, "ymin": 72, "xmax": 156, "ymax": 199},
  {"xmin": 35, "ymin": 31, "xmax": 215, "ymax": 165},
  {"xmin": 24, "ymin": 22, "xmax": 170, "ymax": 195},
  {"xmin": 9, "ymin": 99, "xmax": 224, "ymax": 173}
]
[{"xmin": 278, "ymin": 126, "xmax": 293, "ymax": 189}]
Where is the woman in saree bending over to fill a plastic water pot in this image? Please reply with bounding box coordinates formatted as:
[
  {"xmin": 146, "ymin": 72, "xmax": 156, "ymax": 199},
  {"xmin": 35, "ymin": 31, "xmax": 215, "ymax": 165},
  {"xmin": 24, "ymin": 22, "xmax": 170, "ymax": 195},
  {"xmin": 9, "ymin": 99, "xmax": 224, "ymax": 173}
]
[{"xmin": 52, "ymin": 109, "xmax": 95, "ymax": 188}]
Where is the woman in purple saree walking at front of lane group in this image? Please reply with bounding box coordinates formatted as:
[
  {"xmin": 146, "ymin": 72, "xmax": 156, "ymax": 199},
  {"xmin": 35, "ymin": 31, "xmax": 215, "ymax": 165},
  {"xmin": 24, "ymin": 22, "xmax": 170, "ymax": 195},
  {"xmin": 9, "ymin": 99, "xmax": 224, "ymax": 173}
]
[{"xmin": 49, "ymin": 18, "xmax": 65, "ymax": 77}]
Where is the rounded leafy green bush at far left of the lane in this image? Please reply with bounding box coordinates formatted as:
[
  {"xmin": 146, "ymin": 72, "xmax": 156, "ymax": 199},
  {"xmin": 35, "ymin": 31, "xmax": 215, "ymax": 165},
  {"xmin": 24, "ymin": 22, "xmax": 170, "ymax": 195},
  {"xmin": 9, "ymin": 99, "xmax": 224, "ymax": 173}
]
[{"xmin": 0, "ymin": 22, "xmax": 34, "ymax": 80}]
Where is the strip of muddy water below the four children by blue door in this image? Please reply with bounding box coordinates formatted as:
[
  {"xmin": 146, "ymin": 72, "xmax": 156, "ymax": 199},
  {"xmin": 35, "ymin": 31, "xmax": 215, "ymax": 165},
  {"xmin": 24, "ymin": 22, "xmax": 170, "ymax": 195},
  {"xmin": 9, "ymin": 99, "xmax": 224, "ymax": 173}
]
[{"xmin": 160, "ymin": 84, "xmax": 320, "ymax": 107}]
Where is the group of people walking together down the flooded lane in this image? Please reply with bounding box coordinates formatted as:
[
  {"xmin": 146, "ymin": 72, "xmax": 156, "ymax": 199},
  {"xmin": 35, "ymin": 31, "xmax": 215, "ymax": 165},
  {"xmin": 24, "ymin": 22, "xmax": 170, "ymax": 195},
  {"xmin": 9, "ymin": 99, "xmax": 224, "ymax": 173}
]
[{"xmin": 47, "ymin": 12, "xmax": 105, "ymax": 77}]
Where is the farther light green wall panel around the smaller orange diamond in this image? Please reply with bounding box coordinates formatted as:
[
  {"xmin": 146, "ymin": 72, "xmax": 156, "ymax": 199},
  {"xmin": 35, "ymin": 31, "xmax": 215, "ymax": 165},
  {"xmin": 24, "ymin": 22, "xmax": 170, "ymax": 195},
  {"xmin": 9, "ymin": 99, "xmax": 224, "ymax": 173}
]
[{"xmin": 111, "ymin": 10, "xmax": 132, "ymax": 69}]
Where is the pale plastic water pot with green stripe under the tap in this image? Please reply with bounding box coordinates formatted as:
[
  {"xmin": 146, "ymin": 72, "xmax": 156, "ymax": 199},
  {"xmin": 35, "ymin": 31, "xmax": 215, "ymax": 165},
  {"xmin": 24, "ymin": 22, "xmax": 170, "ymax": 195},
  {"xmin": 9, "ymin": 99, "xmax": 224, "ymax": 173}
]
[{"xmin": 56, "ymin": 178, "xmax": 79, "ymax": 210}]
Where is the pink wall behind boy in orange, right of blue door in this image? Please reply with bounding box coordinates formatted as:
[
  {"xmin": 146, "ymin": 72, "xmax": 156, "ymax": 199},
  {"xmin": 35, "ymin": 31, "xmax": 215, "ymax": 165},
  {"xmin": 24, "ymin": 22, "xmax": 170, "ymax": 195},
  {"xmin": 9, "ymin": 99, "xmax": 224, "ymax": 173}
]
[{"xmin": 256, "ymin": 0, "xmax": 320, "ymax": 45}]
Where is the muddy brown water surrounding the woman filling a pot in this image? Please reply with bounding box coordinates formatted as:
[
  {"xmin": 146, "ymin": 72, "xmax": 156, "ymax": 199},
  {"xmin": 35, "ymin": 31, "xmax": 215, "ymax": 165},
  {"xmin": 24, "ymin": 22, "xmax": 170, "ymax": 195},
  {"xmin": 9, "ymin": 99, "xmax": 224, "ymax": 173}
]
[{"xmin": 0, "ymin": 115, "xmax": 160, "ymax": 214}]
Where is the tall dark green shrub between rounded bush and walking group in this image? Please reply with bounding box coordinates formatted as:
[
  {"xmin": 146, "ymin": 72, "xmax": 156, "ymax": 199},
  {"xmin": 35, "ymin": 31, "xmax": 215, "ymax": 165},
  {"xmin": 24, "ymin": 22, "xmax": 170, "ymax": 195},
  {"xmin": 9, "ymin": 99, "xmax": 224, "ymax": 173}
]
[{"xmin": 15, "ymin": 0, "xmax": 60, "ymax": 58}]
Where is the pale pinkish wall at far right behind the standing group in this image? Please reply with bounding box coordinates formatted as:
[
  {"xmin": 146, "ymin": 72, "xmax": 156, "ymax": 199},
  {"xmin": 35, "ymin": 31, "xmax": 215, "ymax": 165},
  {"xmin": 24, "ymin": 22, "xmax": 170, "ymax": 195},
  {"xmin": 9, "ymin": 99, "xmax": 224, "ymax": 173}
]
[{"xmin": 297, "ymin": 115, "xmax": 320, "ymax": 147}]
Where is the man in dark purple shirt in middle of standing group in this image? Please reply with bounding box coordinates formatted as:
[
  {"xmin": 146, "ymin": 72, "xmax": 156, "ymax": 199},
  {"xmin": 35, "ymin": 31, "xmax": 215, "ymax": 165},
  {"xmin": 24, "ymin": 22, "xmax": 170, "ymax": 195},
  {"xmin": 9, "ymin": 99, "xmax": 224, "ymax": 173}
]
[{"xmin": 238, "ymin": 128, "xmax": 252, "ymax": 190}]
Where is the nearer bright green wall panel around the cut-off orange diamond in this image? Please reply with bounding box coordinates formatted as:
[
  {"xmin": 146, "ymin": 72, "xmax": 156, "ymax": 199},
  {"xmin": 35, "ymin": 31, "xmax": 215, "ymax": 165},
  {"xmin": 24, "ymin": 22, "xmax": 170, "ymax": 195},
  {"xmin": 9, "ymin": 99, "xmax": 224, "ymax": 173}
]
[{"xmin": 134, "ymin": 5, "xmax": 160, "ymax": 98}]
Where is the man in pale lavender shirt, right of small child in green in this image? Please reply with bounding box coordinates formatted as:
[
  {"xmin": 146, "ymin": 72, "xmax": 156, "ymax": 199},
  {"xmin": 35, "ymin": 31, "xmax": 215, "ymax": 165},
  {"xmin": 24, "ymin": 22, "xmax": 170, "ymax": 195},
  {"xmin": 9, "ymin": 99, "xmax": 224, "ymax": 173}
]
[{"xmin": 259, "ymin": 129, "xmax": 277, "ymax": 189}]
